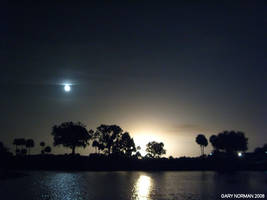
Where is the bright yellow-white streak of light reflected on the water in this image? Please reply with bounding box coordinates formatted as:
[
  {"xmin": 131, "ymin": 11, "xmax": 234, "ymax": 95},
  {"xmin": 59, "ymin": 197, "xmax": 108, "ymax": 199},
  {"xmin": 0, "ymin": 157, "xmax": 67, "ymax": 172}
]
[{"xmin": 133, "ymin": 175, "xmax": 152, "ymax": 200}]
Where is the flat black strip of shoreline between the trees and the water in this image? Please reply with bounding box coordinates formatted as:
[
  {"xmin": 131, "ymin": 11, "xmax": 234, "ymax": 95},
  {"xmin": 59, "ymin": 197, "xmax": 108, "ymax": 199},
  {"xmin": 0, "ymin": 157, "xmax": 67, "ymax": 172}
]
[{"xmin": 2, "ymin": 154, "xmax": 267, "ymax": 171}]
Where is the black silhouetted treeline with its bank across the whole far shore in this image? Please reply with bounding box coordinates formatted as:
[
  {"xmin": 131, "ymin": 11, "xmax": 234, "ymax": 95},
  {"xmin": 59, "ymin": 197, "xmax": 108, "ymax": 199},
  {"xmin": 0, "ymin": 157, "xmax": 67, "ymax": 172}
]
[{"xmin": 0, "ymin": 122, "xmax": 267, "ymax": 170}]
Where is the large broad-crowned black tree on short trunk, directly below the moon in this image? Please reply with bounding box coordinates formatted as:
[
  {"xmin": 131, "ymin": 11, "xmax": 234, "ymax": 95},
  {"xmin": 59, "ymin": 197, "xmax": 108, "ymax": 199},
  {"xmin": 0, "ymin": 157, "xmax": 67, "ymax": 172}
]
[{"xmin": 51, "ymin": 122, "xmax": 92, "ymax": 154}]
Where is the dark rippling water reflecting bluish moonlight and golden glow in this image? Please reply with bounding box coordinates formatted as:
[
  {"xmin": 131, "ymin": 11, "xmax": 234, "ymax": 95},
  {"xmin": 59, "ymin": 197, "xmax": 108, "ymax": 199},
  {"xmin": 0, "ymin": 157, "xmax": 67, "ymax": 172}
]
[{"xmin": 0, "ymin": 171, "xmax": 267, "ymax": 200}]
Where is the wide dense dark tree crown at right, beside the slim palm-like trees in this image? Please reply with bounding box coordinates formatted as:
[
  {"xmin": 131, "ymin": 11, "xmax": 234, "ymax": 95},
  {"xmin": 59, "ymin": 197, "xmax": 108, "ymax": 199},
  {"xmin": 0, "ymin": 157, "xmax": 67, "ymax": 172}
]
[{"xmin": 210, "ymin": 131, "xmax": 248, "ymax": 154}]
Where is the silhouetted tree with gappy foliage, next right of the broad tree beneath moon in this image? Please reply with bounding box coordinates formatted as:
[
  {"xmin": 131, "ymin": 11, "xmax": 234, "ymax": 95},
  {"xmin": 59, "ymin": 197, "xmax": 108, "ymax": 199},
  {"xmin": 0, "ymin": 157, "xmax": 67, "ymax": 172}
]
[{"xmin": 94, "ymin": 124, "xmax": 123, "ymax": 155}]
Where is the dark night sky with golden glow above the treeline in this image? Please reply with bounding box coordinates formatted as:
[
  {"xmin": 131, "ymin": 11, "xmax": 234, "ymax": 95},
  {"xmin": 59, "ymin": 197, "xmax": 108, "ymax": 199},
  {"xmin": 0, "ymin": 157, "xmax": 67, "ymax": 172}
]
[{"xmin": 0, "ymin": 1, "xmax": 267, "ymax": 156}]
